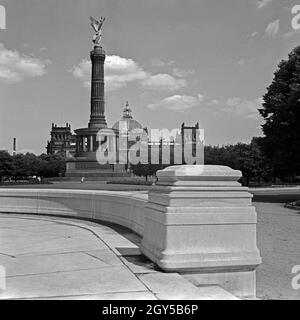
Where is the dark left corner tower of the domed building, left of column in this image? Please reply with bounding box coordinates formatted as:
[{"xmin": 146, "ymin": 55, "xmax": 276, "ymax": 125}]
[{"xmin": 46, "ymin": 123, "xmax": 76, "ymax": 158}]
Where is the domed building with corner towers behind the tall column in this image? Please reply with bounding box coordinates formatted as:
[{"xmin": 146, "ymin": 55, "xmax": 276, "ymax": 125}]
[{"xmin": 47, "ymin": 112, "xmax": 201, "ymax": 168}]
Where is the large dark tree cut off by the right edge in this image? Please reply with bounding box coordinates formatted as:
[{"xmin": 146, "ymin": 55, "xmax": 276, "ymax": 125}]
[{"xmin": 259, "ymin": 46, "xmax": 300, "ymax": 180}]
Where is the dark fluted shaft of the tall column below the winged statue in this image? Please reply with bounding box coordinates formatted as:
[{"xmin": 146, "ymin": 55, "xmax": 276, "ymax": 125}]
[{"xmin": 89, "ymin": 46, "xmax": 107, "ymax": 129}]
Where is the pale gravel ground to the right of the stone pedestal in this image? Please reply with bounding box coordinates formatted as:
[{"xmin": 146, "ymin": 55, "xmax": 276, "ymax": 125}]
[{"xmin": 254, "ymin": 203, "xmax": 300, "ymax": 300}]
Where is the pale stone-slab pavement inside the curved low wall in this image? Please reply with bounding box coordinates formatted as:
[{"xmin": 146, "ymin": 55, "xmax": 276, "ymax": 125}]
[{"xmin": 0, "ymin": 214, "xmax": 235, "ymax": 300}]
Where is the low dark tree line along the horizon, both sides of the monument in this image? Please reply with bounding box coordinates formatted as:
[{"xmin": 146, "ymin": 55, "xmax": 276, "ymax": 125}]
[{"xmin": 0, "ymin": 138, "xmax": 286, "ymax": 185}]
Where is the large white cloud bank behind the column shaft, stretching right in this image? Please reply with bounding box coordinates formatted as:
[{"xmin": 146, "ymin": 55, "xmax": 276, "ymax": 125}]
[{"xmin": 70, "ymin": 55, "xmax": 187, "ymax": 91}]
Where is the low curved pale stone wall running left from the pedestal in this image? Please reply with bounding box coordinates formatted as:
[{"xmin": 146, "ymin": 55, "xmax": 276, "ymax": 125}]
[{"xmin": 0, "ymin": 189, "xmax": 148, "ymax": 236}]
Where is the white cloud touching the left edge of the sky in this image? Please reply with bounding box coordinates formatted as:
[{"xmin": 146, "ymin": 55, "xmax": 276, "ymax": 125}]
[{"xmin": 0, "ymin": 43, "xmax": 51, "ymax": 84}]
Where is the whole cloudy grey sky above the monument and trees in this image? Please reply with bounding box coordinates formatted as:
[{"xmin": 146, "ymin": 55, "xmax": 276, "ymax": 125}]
[{"xmin": 0, "ymin": 0, "xmax": 300, "ymax": 154}]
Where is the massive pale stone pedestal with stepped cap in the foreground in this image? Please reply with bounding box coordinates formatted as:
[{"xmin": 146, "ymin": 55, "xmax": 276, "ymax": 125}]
[{"xmin": 141, "ymin": 165, "xmax": 261, "ymax": 298}]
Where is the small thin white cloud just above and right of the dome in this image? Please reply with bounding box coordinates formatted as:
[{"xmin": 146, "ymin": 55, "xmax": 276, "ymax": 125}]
[{"xmin": 148, "ymin": 94, "xmax": 202, "ymax": 112}]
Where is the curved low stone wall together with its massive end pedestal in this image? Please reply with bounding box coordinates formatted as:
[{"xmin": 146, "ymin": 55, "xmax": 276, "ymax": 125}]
[{"xmin": 0, "ymin": 165, "xmax": 261, "ymax": 298}]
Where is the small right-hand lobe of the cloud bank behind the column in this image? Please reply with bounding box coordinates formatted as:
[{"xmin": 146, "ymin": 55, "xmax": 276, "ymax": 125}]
[{"xmin": 142, "ymin": 73, "xmax": 187, "ymax": 91}]
